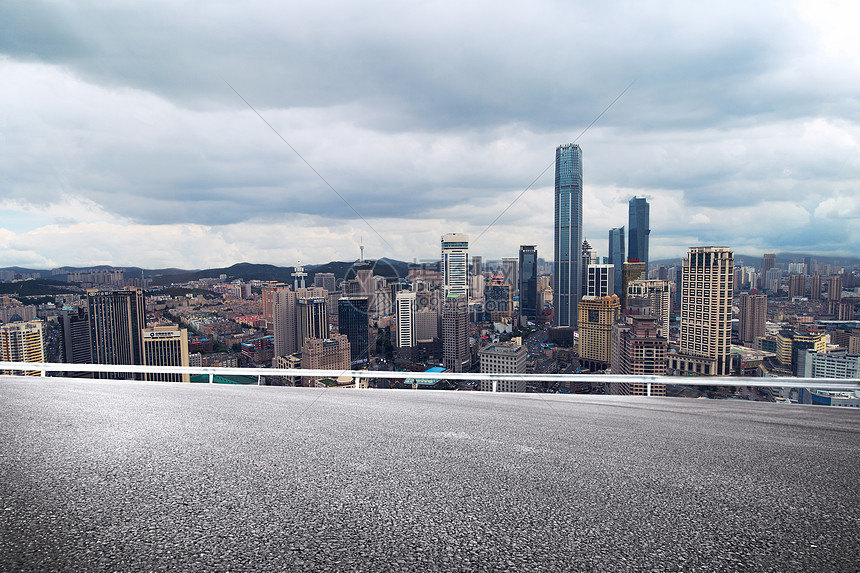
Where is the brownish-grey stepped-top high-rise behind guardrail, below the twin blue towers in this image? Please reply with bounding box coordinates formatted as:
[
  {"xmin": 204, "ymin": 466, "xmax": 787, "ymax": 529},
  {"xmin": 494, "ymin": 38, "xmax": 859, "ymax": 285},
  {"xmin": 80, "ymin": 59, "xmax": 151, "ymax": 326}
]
[{"xmin": 609, "ymin": 315, "xmax": 668, "ymax": 396}]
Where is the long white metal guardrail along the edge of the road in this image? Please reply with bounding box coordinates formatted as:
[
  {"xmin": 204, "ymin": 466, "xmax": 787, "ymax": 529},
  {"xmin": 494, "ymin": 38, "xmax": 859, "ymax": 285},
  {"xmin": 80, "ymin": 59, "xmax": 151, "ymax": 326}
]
[{"xmin": 0, "ymin": 362, "xmax": 860, "ymax": 395}]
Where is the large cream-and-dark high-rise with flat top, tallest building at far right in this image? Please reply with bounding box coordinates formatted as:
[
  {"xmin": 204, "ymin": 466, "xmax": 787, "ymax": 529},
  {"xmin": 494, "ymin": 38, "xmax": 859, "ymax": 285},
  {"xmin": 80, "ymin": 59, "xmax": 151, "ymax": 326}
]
[{"xmin": 670, "ymin": 247, "xmax": 735, "ymax": 376}]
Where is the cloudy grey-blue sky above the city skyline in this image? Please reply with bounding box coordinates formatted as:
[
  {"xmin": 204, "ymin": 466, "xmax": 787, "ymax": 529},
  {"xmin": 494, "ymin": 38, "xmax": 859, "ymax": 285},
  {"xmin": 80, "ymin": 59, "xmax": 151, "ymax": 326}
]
[{"xmin": 0, "ymin": 0, "xmax": 860, "ymax": 268}]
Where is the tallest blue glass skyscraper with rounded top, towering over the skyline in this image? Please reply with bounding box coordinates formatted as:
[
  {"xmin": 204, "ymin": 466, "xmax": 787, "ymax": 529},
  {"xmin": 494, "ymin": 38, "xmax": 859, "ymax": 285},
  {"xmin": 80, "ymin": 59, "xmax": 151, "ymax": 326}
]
[{"xmin": 552, "ymin": 143, "xmax": 582, "ymax": 326}]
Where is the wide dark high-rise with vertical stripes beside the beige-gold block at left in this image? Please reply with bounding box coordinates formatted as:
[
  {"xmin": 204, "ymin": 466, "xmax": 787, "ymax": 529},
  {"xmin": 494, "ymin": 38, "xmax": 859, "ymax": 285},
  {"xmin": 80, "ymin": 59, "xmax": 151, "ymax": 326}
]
[{"xmin": 87, "ymin": 287, "xmax": 146, "ymax": 378}]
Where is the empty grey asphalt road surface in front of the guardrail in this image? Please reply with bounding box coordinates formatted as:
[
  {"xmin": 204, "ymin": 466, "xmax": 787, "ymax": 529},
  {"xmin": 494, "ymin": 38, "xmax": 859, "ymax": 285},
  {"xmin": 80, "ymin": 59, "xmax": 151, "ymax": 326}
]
[{"xmin": 0, "ymin": 378, "xmax": 860, "ymax": 572}]
